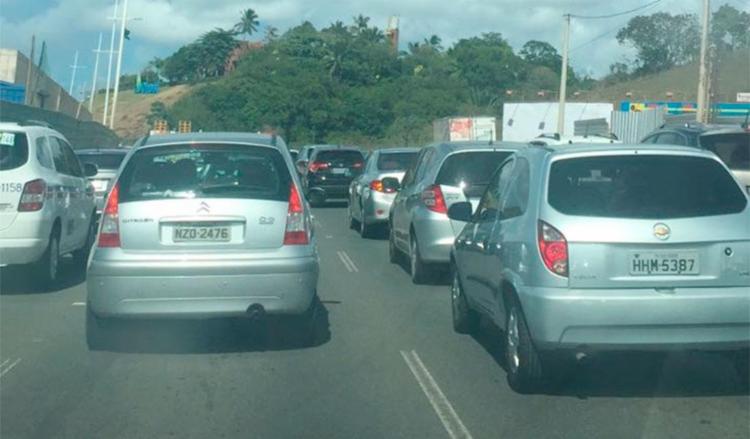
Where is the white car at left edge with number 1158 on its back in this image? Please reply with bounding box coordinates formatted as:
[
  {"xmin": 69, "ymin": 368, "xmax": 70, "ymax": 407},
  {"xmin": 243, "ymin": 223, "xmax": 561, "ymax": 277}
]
[{"xmin": 0, "ymin": 122, "xmax": 96, "ymax": 288}]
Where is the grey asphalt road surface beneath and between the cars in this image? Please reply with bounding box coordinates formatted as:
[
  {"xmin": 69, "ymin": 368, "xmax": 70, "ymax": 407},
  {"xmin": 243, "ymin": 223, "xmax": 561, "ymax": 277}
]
[{"xmin": 0, "ymin": 207, "xmax": 750, "ymax": 439}]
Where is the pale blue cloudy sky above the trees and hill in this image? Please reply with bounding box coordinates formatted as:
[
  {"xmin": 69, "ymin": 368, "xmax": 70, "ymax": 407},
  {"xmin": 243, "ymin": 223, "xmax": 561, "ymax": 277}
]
[{"xmin": 0, "ymin": 0, "xmax": 736, "ymax": 99}]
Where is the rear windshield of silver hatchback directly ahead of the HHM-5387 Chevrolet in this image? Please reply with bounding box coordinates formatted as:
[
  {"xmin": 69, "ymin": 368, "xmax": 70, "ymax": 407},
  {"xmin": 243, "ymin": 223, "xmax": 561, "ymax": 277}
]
[{"xmin": 435, "ymin": 151, "xmax": 512, "ymax": 197}]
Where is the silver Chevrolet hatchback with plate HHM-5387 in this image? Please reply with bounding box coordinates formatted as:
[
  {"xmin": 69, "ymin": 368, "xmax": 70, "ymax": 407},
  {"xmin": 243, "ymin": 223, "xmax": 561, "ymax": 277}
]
[{"xmin": 448, "ymin": 145, "xmax": 750, "ymax": 391}]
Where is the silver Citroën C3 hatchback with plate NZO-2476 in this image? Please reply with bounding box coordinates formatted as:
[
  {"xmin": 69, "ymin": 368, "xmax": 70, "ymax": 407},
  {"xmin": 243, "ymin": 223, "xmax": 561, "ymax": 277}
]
[{"xmin": 86, "ymin": 133, "xmax": 319, "ymax": 349}]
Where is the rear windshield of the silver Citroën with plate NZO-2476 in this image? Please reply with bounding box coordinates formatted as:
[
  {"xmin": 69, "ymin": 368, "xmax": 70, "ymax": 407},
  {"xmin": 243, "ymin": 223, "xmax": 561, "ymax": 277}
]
[{"xmin": 120, "ymin": 144, "xmax": 292, "ymax": 202}]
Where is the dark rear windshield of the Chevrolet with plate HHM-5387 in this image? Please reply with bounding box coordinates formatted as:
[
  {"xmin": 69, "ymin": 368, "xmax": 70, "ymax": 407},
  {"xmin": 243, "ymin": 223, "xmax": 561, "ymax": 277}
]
[{"xmin": 548, "ymin": 155, "xmax": 747, "ymax": 219}]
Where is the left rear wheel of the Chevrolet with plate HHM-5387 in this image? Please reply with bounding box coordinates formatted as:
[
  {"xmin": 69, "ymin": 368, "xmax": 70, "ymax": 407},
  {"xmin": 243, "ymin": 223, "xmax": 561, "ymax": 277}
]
[{"xmin": 504, "ymin": 298, "xmax": 543, "ymax": 393}]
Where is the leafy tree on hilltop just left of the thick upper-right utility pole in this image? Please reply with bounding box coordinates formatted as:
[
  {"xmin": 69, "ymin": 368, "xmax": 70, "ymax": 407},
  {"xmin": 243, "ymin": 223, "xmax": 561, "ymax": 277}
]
[{"xmin": 617, "ymin": 12, "xmax": 700, "ymax": 74}]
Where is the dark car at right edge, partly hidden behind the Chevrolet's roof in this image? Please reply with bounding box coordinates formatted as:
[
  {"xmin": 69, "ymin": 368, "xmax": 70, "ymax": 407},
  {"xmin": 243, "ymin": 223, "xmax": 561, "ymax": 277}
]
[{"xmin": 641, "ymin": 123, "xmax": 750, "ymax": 193}]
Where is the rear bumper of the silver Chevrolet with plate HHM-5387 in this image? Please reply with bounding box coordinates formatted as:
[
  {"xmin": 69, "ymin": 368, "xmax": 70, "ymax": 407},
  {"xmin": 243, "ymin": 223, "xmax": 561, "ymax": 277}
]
[{"xmin": 520, "ymin": 287, "xmax": 750, "ymax": 351}]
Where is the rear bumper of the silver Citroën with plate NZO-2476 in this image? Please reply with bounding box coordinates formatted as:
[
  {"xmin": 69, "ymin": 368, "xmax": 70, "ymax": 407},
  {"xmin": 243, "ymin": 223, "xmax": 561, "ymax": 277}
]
[{"xmin": 86, "ymin": 257, "xmax": 318, "ymax": 318}]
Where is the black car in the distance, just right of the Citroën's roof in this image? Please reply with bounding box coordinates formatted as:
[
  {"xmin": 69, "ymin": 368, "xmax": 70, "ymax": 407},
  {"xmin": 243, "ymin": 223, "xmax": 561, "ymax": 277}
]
[{"xmin": 302, "ymin": 146, "xmax": 365, "ymax": 205}]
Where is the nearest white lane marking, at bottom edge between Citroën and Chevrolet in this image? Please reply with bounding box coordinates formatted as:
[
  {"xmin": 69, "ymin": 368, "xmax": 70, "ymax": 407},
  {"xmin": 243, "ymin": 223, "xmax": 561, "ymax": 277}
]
[{"xmin": 401, "ymin": 351, "xmax": 472, "ymax": 439}]
